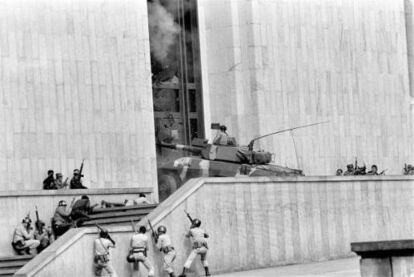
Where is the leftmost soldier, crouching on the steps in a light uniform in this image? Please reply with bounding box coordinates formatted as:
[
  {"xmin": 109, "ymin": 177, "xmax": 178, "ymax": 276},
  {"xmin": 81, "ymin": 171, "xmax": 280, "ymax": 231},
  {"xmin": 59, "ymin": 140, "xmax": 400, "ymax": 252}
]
[{"xmin": 12, "ymin": 216, "xmax": 40, "ymax": 255}]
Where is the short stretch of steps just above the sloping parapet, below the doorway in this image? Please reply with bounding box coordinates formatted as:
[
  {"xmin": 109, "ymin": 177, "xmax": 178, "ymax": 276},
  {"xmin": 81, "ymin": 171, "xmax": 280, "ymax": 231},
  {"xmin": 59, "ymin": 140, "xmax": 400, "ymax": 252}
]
[{"xmin": 82, "ymin": 204, "xmax": 157, "ymax": 227}]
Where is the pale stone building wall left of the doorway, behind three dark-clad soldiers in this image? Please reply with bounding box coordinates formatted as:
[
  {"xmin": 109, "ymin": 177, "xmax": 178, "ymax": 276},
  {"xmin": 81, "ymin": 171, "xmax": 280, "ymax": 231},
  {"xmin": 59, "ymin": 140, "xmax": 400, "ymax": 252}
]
[{"xmin": 0, "ymin": 0, "xmax": 156, "ymax": 190}]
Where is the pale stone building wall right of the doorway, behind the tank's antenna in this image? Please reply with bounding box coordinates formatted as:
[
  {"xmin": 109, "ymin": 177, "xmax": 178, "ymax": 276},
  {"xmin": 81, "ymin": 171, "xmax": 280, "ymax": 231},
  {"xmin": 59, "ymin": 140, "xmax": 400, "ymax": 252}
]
[{"xmin": 198, "ymin": 0, "xmax": 414, "ymax": 175}]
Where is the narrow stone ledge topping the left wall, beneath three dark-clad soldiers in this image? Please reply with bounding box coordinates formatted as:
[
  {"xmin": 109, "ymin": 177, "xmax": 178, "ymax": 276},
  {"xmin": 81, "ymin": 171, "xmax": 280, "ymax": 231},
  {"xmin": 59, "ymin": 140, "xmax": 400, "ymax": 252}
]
[{"xmin": 0, "ymin": 187, "xmax": 154, "ymax": 197}]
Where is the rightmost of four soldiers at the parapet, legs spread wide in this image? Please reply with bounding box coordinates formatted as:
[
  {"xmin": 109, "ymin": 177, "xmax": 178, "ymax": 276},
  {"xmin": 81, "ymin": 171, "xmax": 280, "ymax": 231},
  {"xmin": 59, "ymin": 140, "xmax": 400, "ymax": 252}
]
[{"xmin": 179, "ymin": 218, "xmax": 210, "ymax": 277}]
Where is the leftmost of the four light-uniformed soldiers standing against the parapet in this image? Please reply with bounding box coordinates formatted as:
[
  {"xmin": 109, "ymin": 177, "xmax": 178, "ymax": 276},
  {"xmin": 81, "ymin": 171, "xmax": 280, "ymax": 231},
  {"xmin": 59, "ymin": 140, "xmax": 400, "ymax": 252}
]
[{"xmin": 94, "ymin": 228, "xmax": 116, "ymax": 276}]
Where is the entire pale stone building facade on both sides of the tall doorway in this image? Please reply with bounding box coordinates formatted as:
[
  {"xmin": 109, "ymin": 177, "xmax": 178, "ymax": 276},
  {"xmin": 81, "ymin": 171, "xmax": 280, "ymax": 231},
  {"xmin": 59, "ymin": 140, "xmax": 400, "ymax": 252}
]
[{"xmin": 0, "ymin": 0, "xmax": 413, "ymax": 193}]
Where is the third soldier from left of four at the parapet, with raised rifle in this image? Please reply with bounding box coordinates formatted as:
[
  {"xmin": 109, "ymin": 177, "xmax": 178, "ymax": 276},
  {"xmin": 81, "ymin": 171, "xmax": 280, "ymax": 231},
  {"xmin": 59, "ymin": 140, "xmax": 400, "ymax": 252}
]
[{"xmin": 148, "ymin": 220, "xmax": 176, "ymax": 277}]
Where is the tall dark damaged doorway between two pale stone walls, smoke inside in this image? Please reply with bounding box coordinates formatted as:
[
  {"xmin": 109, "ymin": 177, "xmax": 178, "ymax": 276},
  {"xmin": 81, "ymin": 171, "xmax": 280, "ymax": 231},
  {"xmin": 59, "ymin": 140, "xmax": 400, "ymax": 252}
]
[{"xmin": 147, "ymin": 0, "xmax": 204, "ymax": 201}]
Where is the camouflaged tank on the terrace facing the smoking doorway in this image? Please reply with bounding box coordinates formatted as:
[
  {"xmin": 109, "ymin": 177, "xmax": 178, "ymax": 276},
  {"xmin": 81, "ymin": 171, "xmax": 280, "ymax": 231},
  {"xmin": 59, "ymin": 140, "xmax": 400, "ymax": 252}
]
[{"xmin": 158, "ymin": 138, "xmax": 304, "ymax": 201}]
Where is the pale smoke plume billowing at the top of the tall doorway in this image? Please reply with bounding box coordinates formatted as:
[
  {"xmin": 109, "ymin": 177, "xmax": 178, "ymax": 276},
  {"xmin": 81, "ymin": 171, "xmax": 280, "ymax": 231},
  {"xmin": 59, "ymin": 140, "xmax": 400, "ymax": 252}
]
[{"xmin": 148, "ymin": 0, "xmax": 180, "ymax": 64}]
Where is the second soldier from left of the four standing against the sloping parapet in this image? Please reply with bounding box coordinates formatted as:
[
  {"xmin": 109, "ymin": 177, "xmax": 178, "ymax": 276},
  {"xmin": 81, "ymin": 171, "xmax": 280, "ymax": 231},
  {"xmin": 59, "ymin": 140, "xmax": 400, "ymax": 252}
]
[{"xmin": 127, "ymin": 226, "xmax": 154, "ymax": 277}]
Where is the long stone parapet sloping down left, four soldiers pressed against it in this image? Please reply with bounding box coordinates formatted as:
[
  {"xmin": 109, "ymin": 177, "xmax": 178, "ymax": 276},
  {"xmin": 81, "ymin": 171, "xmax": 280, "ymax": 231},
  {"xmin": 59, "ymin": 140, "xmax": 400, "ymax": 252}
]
[{"xmin": 18, "ymin": 176, "xmax": 414, "ymax": 277}]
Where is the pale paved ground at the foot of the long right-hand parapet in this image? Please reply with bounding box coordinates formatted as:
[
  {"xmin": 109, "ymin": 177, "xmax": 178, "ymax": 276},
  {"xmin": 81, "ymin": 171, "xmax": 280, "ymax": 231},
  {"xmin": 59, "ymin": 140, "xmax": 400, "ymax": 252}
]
[{"xmin": 214, "ymin": 258, "xmax": 360, "ymax": 277}]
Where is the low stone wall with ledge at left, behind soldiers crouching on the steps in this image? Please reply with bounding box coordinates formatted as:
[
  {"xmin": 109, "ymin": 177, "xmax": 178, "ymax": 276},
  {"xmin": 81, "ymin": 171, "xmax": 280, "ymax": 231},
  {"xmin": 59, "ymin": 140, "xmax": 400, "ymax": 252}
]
[{"xmin": 0, "ymin": 188, "xmax": 153, "ymax": 256}]
